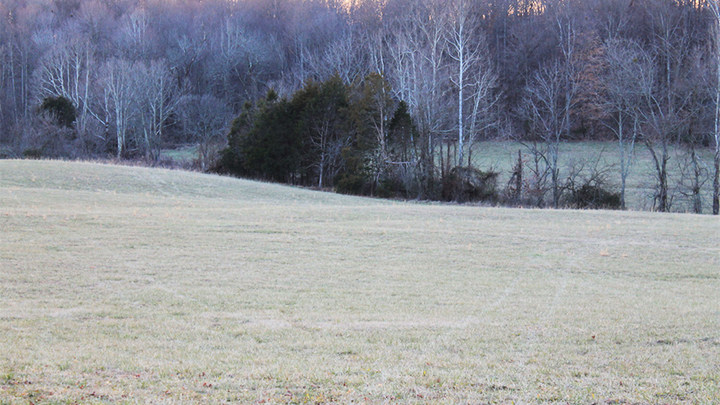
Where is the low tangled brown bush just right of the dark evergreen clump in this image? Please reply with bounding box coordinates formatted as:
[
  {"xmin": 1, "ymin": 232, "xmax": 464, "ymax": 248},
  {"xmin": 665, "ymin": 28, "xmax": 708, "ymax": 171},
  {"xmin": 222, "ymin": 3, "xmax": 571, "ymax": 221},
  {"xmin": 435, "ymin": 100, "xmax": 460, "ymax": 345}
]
[{"xmin": 442, "ymin": 166, "xmax": 498, "ymax": 203}]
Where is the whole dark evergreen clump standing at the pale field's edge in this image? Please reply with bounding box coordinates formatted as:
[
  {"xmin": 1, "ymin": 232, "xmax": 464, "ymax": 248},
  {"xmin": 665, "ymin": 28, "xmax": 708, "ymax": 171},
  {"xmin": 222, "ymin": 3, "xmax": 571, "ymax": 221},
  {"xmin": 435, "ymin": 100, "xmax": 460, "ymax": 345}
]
[{"xmin": 215, "ymin": 74, "xmax": 462, "ymax": 199}]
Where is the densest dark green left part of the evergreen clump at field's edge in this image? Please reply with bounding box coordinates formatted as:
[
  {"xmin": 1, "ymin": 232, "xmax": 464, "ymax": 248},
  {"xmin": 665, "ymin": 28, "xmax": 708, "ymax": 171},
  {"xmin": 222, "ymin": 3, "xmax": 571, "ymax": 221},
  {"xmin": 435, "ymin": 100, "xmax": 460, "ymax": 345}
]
[{"xmin": 217, "ymin": 77, "xmax": 352, "ymax": 186}]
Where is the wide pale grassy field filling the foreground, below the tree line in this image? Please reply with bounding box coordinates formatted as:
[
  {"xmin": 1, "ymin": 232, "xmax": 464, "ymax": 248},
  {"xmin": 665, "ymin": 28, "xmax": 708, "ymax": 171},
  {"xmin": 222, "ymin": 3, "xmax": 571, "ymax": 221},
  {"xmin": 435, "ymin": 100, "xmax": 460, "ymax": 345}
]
[{"xmin": 0, "ymin": 160, "xmax": 720, "ymax": 405}]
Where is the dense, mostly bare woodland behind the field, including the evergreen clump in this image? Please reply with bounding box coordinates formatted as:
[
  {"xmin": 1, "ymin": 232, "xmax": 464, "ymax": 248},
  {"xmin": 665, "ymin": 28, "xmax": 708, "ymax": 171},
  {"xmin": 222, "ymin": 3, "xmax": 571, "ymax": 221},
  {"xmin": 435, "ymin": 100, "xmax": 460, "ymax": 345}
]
[{"xmin": 0, "ymin": 0, "xmax": 720, "ymax": 214}]
